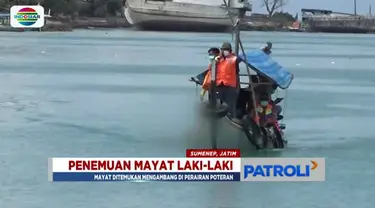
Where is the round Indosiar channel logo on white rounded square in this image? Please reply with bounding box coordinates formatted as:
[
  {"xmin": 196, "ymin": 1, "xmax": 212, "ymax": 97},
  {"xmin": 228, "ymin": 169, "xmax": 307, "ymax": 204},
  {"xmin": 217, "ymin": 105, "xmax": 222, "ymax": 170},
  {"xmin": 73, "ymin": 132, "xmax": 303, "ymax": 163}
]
[{"xmin": 10, "ymin": 5, "xmax": 44, "ymax": 28}]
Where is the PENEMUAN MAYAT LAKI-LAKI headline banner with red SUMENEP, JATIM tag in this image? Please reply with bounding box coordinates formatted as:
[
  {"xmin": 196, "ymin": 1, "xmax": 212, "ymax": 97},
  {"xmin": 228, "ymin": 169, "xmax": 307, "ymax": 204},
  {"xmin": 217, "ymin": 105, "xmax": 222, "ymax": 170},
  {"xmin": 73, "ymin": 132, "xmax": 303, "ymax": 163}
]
[{"xmin": 49, "ymin": 149, "xmax": 241, "ymax": 181}]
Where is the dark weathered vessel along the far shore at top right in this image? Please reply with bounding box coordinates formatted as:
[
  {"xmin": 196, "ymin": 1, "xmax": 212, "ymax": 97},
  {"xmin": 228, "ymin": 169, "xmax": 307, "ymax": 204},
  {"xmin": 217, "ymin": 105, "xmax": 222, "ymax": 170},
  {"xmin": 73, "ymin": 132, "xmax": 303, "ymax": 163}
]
[{"xmin": 301, "ymin": 9, "xmax": 375, "ymax": 33}]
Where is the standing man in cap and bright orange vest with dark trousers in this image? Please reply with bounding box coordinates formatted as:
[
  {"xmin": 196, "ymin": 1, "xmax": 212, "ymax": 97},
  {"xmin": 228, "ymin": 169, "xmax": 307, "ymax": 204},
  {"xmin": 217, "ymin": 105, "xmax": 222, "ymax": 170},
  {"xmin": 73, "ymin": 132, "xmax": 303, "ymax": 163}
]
[{"xmin": 216, "ymin": 42, "xmax": 241, "ymax": 117}]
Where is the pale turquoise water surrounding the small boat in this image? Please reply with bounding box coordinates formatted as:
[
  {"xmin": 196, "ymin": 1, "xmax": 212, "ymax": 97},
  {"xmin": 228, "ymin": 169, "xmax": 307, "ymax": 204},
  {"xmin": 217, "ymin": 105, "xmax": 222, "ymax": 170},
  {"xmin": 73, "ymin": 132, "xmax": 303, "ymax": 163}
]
[{"xmin": 0, "ymin": 30, "xmax": 375, "ymax": 208}]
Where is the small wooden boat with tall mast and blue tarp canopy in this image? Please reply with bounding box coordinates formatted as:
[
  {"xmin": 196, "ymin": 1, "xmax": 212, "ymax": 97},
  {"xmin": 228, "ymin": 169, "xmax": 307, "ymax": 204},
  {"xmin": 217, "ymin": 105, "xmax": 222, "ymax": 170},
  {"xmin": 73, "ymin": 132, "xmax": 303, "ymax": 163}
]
[{"xmin": 190, "ymin": 0, "xmax": 293, "ymax": 150}]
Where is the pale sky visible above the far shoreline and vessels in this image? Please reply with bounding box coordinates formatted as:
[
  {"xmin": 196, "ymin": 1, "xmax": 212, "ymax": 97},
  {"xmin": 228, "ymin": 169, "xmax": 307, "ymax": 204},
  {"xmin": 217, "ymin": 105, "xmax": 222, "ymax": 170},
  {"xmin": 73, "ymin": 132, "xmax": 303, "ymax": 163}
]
[{"xmin": 178, "ymin": 0, "xmax": 375, "ymax": 15}]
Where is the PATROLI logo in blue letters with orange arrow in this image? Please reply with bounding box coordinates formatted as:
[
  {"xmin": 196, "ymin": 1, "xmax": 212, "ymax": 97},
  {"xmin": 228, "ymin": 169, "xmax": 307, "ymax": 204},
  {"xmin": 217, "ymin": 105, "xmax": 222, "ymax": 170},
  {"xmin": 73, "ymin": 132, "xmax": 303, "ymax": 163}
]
[{"xmin": 242, "ymin": 158, "xmax": 325, "ymax": 181}]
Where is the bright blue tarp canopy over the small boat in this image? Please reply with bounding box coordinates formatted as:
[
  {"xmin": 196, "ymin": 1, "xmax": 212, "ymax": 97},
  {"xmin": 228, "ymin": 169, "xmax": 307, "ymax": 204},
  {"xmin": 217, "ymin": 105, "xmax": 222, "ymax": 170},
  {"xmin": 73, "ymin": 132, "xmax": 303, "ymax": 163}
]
[{"xmin": 239, "ymin": 50, "xmax": 293, "ymax": 89}]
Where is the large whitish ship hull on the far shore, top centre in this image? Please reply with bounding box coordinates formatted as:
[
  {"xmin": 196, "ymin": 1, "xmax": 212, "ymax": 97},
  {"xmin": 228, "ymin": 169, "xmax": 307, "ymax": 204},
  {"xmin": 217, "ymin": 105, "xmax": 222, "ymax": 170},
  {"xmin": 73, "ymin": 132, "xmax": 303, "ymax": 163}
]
[{"xmin": 125, "ymin": 0, "xmax": 233, "ymax": 32}]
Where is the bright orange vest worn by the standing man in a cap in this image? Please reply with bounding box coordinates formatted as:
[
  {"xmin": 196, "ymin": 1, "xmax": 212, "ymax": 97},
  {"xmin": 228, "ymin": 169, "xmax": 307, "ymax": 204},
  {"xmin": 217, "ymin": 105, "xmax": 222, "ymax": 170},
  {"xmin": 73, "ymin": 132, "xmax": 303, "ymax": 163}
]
[{"xmin": 216, "ymin": 54, "xmax": 237, "ymax": 87}]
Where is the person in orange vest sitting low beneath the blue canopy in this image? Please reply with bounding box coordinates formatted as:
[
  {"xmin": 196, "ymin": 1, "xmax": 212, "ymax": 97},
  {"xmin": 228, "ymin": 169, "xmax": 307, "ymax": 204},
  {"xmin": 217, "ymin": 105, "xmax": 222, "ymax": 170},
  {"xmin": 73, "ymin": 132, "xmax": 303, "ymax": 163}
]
[{"xmin": 251, "ymin": 93, "xmax": 277, "ymax": 126}]
